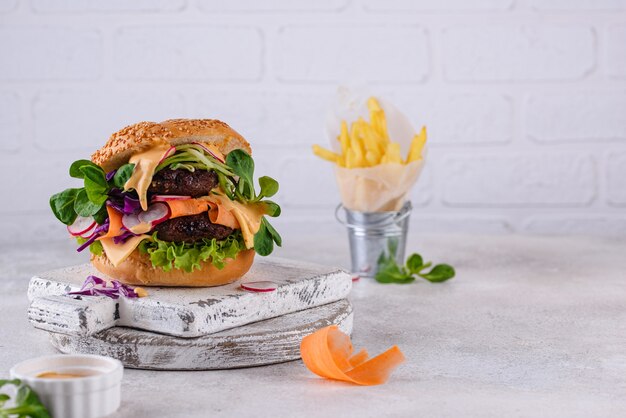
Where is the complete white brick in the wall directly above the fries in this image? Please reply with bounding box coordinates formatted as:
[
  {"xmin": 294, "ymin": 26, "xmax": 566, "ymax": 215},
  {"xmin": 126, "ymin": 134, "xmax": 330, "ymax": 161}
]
[{"xmin": 274, "ymin": 24, "xmax": 430, "ymax": 83}]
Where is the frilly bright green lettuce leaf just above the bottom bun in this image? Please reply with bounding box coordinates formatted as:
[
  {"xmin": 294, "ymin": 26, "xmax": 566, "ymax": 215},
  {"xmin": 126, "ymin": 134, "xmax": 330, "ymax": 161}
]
[{"xmin": 139, "ymin": 231, "xmax": 245, "ymax": 273}]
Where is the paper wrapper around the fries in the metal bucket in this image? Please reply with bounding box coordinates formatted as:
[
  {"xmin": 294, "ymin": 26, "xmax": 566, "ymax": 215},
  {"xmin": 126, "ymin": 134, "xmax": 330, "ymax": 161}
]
[{"xmin": 326, "ymin": 88, "xmax": 426, "ymax": 212}]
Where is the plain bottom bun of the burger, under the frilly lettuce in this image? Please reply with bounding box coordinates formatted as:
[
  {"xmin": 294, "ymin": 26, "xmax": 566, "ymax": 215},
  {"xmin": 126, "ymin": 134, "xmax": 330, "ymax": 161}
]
[{"xmin": 91, "ymin": 250, "xmax": 255, "ymax": 287}]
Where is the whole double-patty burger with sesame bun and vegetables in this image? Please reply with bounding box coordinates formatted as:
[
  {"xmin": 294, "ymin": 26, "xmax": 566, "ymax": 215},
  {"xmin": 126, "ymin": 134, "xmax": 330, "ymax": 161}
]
[{"xmin": 50, "ymin": 119, "xmax": 281, "ymax": 287}]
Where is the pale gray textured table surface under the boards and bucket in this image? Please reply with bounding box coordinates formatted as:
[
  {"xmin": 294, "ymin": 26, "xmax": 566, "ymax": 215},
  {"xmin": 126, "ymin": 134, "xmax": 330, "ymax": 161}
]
[{"xmin": 0, "ymin": 234, "xmax": 626, "ymax": 417}]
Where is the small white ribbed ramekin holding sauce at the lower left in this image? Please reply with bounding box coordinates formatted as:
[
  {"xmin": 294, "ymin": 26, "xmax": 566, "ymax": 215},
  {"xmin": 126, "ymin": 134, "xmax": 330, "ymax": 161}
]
[{"xmin": 11, "ymin": 354, "xmax": 124, "ymax": 418}]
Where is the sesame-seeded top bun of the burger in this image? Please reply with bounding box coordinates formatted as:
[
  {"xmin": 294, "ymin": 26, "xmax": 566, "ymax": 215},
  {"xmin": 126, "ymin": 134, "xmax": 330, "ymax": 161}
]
[{"xmin": 91, "ymin": 119, "xmax": 252, "ymax": 171}]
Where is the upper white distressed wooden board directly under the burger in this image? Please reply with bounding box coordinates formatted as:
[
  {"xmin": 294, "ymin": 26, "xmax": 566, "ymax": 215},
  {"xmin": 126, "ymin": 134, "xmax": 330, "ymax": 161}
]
[{"xmin": 28, "ymin": 258, "xmax": 352, "ymax": 338}]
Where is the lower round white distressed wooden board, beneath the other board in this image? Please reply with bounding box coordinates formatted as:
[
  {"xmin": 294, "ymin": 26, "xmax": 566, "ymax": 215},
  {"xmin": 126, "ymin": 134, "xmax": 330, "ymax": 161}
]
[{"xmin": 50, "ymin": 299, "xmax": 353, "ymax": 370}]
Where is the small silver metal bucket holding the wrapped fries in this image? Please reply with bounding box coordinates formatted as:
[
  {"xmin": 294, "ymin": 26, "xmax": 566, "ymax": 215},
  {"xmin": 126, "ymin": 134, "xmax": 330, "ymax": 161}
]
[{"xmin": 335, "ymin": 202, "xmax": 413, "ymax": 277}]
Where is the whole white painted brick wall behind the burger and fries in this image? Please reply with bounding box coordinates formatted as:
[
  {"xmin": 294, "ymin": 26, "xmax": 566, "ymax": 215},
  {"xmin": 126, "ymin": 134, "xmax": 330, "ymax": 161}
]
[{"xmin": 0, "ymin": 0, "xmax": 626, "ymax": 242}]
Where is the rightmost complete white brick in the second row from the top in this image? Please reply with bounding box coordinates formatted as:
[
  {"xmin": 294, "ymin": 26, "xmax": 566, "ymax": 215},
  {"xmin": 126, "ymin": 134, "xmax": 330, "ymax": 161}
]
[{"xmin": 442, "ymin": 24, "xmax": 596, "ymax": 82}]
